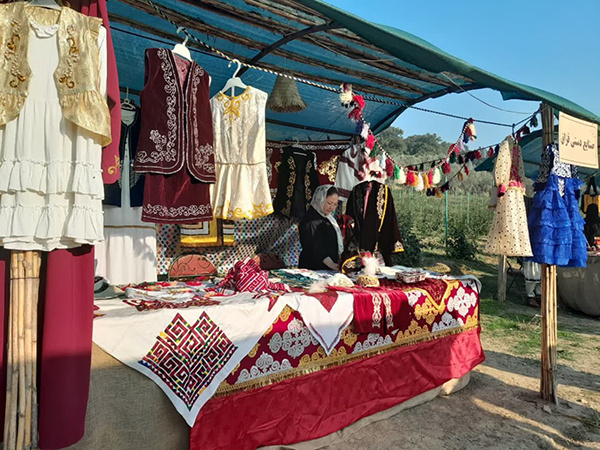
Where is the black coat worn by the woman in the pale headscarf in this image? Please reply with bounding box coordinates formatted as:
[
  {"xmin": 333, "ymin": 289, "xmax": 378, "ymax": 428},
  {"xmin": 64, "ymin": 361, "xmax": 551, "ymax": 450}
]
[{"xmin": 298, "ymin": 206, "xmax": 338, "ymax": 270}]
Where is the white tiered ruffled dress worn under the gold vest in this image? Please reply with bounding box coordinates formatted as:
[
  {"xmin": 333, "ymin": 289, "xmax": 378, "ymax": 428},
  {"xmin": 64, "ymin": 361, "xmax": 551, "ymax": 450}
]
[{"xmin": 0, "ymin": 14, "xmax": 106, "ymax": 251}]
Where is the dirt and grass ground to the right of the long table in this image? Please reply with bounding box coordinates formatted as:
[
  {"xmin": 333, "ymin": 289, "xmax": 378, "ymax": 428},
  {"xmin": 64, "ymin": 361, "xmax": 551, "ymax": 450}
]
[{"xmin": 327, "ymin": 253, "xmax": 600, "ymax": 450}]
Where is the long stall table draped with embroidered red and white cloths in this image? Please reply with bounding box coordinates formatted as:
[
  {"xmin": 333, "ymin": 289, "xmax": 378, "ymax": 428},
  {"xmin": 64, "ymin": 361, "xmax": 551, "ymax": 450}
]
[{"xmin": 73, "ymin": 270, "xmax": 484, "ymax": 450}]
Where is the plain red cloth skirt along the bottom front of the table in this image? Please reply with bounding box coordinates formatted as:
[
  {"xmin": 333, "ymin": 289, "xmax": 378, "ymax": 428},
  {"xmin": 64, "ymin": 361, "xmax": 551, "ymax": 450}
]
[{"xmin": 190, "ymin": 330, "xmax": 485, "ymax": 450}]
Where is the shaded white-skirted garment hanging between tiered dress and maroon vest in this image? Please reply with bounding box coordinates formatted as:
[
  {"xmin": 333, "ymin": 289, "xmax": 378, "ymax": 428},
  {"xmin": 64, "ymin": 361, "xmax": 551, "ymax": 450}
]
[{"xmin": 95, "ymin": 110, "xmax": 157, "ymax": 284}]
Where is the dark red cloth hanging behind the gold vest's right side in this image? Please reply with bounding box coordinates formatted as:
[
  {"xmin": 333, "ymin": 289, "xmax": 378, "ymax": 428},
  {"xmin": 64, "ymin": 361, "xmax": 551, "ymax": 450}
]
[{"xmin": 70, "ymin": 0, "xmax": 121, "ymax": 184}]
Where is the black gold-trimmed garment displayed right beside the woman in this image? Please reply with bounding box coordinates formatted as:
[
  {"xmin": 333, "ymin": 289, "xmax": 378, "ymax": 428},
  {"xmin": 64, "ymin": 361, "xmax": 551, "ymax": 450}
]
[{"xmin": 342, "ymin": 181, "xmax": 404, "ymax": 266}]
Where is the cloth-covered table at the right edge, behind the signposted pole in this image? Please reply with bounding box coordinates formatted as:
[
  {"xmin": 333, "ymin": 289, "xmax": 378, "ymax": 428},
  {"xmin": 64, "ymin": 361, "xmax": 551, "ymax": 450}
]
[{"xmin": 557, "ymin": 253, "xmax": 600, "ymax": 317}]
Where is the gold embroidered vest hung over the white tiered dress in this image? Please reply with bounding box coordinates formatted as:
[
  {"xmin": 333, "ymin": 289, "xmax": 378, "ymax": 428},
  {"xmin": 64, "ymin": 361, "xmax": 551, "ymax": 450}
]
[{"xmin": 0, "ymin": 2, "xmax": 112, "ymax": 147}]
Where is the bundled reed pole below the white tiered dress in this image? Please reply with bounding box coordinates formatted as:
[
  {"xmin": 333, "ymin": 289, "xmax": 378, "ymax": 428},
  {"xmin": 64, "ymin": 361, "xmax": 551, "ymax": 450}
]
[{"xmin": 4, "ymin": 251, "xmax": 41, "ymax": 450}]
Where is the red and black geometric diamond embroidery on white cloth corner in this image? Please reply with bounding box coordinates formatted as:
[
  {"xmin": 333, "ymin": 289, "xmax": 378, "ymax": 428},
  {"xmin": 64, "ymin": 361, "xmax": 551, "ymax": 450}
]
[{"xmin": 139, "ymin": 312, "xmax": 237, "ymax": 410}]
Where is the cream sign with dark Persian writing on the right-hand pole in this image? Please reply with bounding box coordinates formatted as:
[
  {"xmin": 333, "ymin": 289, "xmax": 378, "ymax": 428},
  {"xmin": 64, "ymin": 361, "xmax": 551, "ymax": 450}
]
[{"xmin": 558, "ymin": 112, "xmax": 598, "ymax": 169}]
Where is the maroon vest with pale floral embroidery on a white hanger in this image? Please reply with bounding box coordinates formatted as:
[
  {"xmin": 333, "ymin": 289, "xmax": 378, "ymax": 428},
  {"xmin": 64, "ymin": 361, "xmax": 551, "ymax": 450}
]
[{"xmin": 134, "ymin": 48, "xmax": 216, "ymax": 183}]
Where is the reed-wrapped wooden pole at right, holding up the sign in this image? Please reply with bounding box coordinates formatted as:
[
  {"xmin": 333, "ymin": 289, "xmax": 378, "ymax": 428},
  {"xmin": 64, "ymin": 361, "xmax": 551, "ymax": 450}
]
[{"xmin": 540, "ymin": 104, "xmax": 558, "ymax": 404}]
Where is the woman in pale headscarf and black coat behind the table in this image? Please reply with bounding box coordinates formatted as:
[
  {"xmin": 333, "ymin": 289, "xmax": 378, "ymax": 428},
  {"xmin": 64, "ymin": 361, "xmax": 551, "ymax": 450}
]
[{"xmin": 298, "ymin": 184, "xmax": 344, "ymax": 270}]
